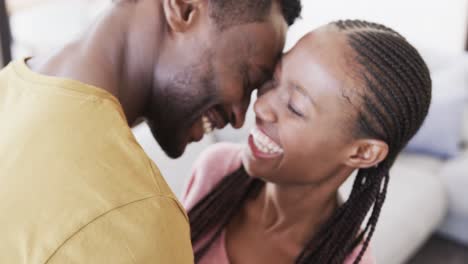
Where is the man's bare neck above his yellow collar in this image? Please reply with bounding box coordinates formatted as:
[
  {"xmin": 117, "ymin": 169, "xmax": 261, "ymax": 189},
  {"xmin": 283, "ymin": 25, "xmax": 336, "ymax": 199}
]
[{"xmin": 28, "ymin": 1, "xmax": 165, "ymax": 125}]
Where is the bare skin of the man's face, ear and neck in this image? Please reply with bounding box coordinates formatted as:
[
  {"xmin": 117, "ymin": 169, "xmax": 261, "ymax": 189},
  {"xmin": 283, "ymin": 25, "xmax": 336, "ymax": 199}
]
[{"xmin": 28, "ymin": 0, "xmax": 287, "ymax": 158}]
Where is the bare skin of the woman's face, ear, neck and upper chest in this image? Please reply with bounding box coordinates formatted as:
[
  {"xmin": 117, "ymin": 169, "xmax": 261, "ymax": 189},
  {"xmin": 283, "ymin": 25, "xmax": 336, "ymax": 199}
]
[{"xmin": 226, "ymin": 26, "xmax": 388, "ymax": 264}]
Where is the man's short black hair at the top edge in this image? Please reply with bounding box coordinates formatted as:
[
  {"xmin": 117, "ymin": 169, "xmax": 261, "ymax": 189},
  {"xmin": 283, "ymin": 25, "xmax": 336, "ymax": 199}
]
[{"xmin": 209, "ymin": 0, "xmax": 302, "ymax": 28}]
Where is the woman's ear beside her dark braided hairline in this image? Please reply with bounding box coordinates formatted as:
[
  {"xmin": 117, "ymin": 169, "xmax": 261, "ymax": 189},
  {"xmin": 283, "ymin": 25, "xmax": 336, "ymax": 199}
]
[{"xmin": 345, "ymin": 139, "xmax": 388, "ymax": 169}]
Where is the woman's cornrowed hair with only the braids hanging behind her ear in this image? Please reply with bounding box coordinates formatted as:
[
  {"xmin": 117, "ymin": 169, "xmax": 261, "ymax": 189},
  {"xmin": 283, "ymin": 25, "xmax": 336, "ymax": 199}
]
[{"xmin": 297, "ymin": 20, "xmax": 431, "ymax": 263}]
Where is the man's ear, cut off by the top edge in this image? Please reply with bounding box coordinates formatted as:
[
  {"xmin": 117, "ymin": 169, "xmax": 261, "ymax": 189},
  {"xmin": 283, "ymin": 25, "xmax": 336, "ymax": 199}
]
[{"xmin": 163, "ymin": 0, "xmax": 200, "ymax": 32}]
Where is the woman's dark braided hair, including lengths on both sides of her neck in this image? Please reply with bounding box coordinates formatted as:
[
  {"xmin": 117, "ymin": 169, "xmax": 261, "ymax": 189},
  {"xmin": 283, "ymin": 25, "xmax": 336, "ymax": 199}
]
[{"xmin": 188, "ymin": 20, "xmax": 432, "ymax": 264}]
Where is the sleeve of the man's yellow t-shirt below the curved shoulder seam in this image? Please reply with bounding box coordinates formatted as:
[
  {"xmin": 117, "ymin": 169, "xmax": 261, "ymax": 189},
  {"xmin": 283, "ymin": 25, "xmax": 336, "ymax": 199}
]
[{"xmin": 45, "ymin": 196, "xmax": 194, "ymax": 264}]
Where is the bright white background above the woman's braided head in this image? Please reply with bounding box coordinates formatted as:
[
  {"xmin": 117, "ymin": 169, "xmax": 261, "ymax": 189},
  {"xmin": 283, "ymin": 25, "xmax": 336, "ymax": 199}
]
[{"xmin": 286, "ymin": 0, "xmax": 468, "ymax": 52}]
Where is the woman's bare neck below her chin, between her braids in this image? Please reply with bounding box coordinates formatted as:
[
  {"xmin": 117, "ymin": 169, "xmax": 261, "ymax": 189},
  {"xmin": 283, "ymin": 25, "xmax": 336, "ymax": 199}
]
[{"xmin": 247, "ymin": 168, "xmax": 349, "ymax": 248}]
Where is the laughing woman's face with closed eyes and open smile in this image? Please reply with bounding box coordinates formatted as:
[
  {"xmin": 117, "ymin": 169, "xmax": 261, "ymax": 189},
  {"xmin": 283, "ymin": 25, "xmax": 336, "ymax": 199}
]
[{"xmin": 242, "ymin": 26, "xmax": 357, "ymax": 184}]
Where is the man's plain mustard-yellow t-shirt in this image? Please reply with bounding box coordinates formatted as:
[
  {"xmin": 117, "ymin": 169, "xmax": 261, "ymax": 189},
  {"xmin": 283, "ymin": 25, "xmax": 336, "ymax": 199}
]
[{"xmin": 0, "ymin": 60, "xmax": 193, "ymax": 264}]
